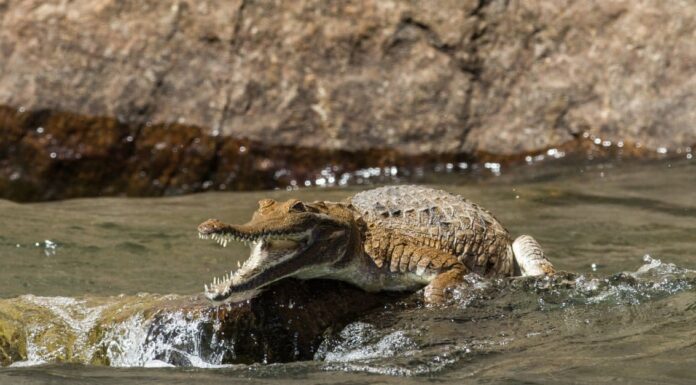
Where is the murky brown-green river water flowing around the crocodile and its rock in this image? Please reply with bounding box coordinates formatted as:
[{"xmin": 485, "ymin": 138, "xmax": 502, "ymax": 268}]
[{"xmin": 0, "ymin": 160, "xmax": 696, "ymax": 384}]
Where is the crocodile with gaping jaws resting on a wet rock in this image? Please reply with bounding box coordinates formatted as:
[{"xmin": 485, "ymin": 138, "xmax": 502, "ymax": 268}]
[{"xmin": 198, "ymin": 185, "xmax": 555, "ymax": 304}]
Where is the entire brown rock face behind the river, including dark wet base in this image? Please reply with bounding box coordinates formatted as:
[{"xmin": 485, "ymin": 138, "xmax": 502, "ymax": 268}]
[{"xmin": 0, "ymin": 0, "xmax": 696, "ymax": 199}]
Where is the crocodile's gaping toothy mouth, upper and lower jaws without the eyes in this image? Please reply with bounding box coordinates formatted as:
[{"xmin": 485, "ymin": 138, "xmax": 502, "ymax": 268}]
[{"xmin": 198, "ymin": 221, "xmax": 312, "ymax": 301}]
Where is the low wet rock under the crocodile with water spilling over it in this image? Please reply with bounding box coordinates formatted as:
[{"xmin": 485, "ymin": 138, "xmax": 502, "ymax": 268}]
[{"xmin": 0, "ymin": 280, "xmax": 396, "ymax": 366}]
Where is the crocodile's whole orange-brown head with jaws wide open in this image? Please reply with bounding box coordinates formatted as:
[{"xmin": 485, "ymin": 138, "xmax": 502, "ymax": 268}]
[{"xmin": 198, "ymin": 199, "xmax": 352, "ymax": 302}]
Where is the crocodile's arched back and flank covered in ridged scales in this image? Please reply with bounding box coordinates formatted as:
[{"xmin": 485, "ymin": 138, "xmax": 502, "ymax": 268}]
[{"xmin": 350, "ymin": 186, "xmax": 513, "ymax": 276}]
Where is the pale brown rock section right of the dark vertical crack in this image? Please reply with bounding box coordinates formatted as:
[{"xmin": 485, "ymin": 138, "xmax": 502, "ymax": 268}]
[{"xmin": 467, "ymin": 0, "xmax": 696, "ymax": 154}]
